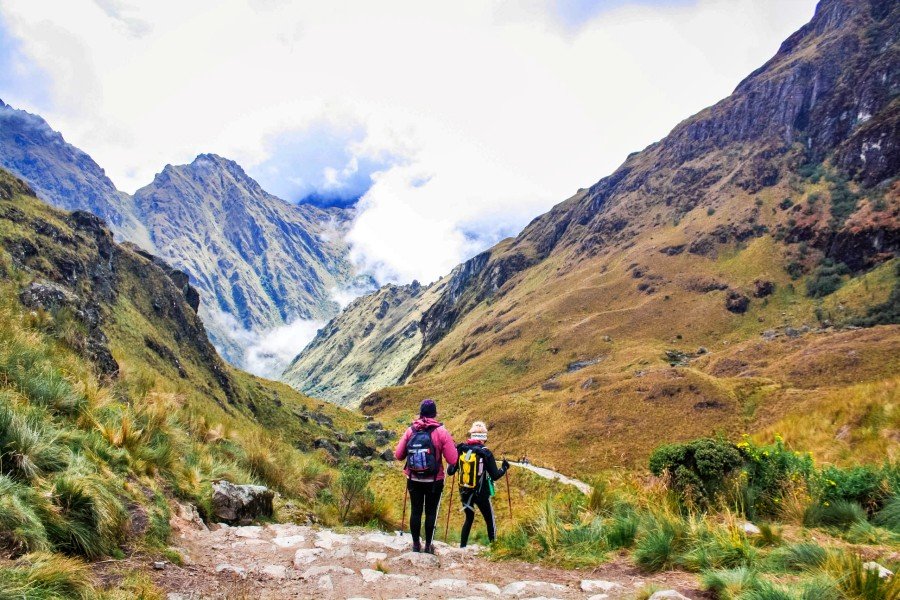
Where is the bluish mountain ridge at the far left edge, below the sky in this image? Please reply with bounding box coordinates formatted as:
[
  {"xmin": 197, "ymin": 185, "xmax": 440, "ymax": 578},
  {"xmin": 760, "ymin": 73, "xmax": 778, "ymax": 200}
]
[{"xmin": 0, "ymin": 101, "xmax": 152, "ymax": 249}]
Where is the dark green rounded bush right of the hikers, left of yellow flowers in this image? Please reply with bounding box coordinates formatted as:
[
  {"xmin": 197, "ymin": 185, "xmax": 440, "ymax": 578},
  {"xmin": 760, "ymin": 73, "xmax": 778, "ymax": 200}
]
[{"xmin": 650, "ymin": 438, "xmax": 741, "ymax": 506}]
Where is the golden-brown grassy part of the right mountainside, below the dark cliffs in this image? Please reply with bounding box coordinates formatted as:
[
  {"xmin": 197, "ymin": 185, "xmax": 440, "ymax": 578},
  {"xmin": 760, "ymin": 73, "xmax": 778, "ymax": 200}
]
[{"xmin": 364, "ymin": 182, "xmax": 900, "ymax": 473}]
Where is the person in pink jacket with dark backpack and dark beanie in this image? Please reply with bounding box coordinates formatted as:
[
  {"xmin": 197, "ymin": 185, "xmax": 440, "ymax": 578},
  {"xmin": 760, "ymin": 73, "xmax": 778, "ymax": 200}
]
[{"xmin": 394, "ymin": 398, "xmax": 459, "ymax": 554}]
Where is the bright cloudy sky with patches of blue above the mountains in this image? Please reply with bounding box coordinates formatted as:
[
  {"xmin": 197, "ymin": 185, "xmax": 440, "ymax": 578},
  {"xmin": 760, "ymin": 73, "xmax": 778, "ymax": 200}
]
[{"xmin": 0, "ymin": 0, "xmax": 815, "ymax": 282}]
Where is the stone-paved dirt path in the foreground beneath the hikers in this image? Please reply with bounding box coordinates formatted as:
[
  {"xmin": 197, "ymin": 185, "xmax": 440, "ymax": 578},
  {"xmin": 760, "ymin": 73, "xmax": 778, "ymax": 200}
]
[{"xmin": 152, "ymin": 510, "xmax": 700, "ymax": 600}]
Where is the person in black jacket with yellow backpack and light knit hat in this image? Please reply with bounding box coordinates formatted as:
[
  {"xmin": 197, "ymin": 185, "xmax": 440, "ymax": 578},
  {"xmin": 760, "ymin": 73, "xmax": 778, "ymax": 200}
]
[{"xmin": 447, "ymin": 421, "xmax": 509, "ymax": 548}]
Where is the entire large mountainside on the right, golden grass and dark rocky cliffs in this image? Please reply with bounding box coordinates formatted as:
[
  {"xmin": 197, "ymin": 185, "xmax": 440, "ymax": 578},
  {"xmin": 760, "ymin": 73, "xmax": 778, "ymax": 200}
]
[{"xmin": 326, "ymin": 0, "xmax": 900, "ymax": 468}]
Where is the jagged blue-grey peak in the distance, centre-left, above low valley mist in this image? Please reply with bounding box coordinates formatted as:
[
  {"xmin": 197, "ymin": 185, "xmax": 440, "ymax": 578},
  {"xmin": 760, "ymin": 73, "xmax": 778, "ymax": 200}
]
[{"xmin": 134, "ymin": 154, "xmax": 353, "ymax": 364}]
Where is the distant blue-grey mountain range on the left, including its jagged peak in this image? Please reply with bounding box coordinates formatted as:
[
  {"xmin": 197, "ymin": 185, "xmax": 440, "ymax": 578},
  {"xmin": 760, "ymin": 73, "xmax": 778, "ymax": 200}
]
[{"xmin": 0, "ymin": 103, "xmax": 358, "ymax": 368}]
